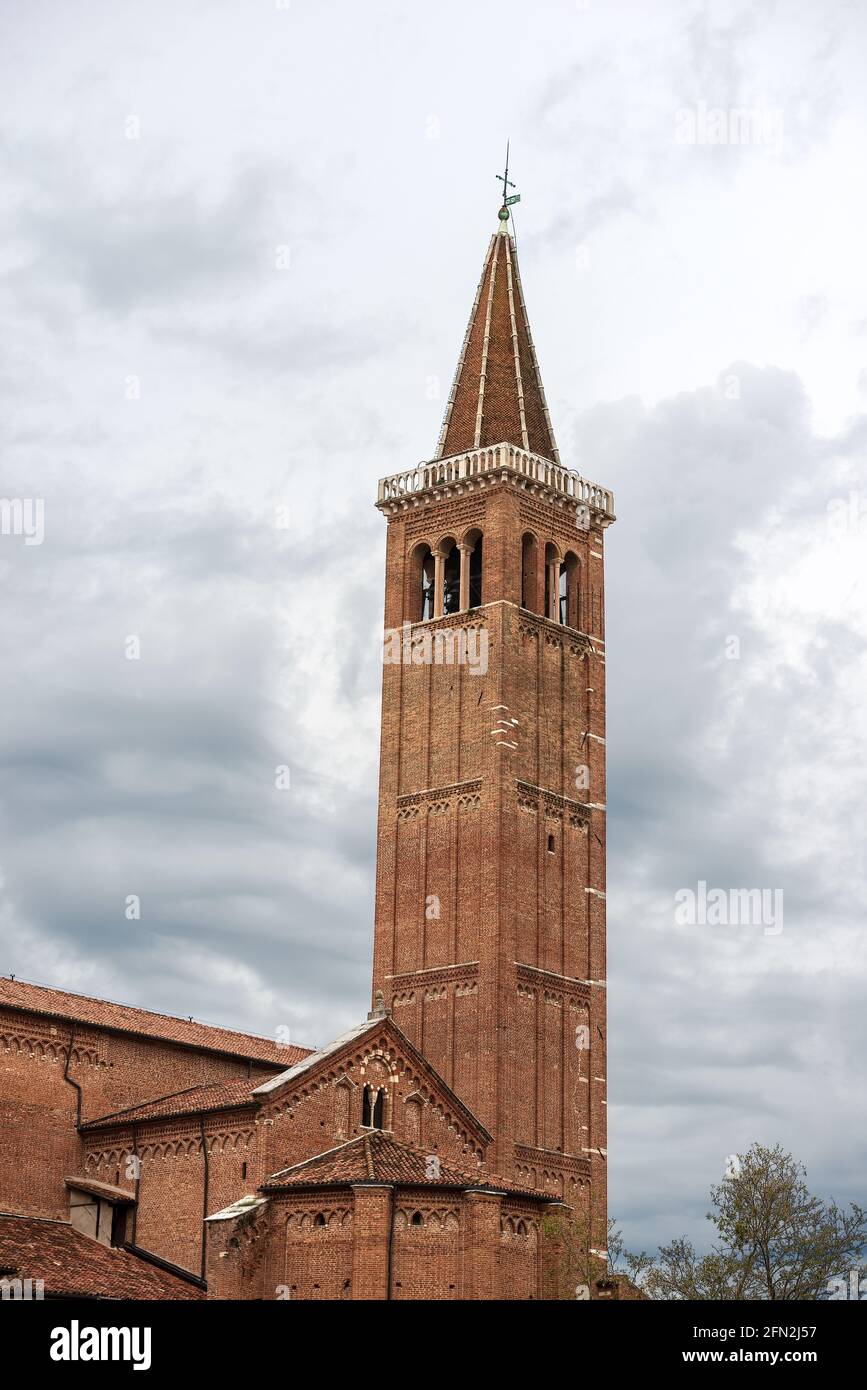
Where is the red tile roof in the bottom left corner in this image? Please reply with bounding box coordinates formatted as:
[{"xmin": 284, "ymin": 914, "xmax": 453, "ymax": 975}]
[{"xmin": 0, "ymin": 1215, "xmax": 204, "ymax": 1300}]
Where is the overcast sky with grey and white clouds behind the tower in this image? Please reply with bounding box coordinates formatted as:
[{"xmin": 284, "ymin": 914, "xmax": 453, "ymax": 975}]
[{"xmin": 0, "ymin": 0, "xmax": 867, "ymax": 1247}]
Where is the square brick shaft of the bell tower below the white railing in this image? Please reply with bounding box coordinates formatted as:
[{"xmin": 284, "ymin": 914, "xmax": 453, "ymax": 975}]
[{"xmin": 374, "ymin": 482, "xmax": 607, "ymax": 1248}]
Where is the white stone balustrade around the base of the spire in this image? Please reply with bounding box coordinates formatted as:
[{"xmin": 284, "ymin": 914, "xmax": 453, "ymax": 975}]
[{"xmin": 377, "ymin": 443, "xmax": 614, "ymax": 517}]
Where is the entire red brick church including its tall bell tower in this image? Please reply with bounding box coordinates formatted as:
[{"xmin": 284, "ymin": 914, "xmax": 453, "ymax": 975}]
[{"xmin": 0, "ymin": 198, "xmax": 616, "ymax": 1300}]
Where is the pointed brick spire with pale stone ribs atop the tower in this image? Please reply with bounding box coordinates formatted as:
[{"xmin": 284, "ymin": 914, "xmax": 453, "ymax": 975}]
[{"xmin": 435, "ymin": 209, "xmax": 560, "ymax": 463}]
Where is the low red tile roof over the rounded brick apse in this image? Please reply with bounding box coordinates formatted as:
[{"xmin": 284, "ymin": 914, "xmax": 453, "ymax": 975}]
[{"xmin": 261, "ymin": 1130, "xmax": 550, "ymax": 1201}]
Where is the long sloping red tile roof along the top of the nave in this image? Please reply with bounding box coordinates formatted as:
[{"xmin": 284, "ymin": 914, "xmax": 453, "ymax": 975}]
[{"xmin": 0, "ymin": 976, "xmax": 310, "ymax": 1068}]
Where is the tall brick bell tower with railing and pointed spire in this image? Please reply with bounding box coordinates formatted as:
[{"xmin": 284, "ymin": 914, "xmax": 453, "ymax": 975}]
[{"xmin": 374, "ymin": 187, "xmax": 614, "ymax": 1251}]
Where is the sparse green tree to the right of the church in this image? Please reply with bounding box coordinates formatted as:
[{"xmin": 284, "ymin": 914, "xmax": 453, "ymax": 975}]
[{"xmin": 616, "ymin": 1144, "xmax": 867, "ymax": 1301}]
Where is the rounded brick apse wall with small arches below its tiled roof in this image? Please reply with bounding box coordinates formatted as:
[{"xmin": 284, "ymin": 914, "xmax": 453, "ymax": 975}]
[{"xmin": 207, "ymin": 1183, "xmax": 566, "ymax": 1302}]
